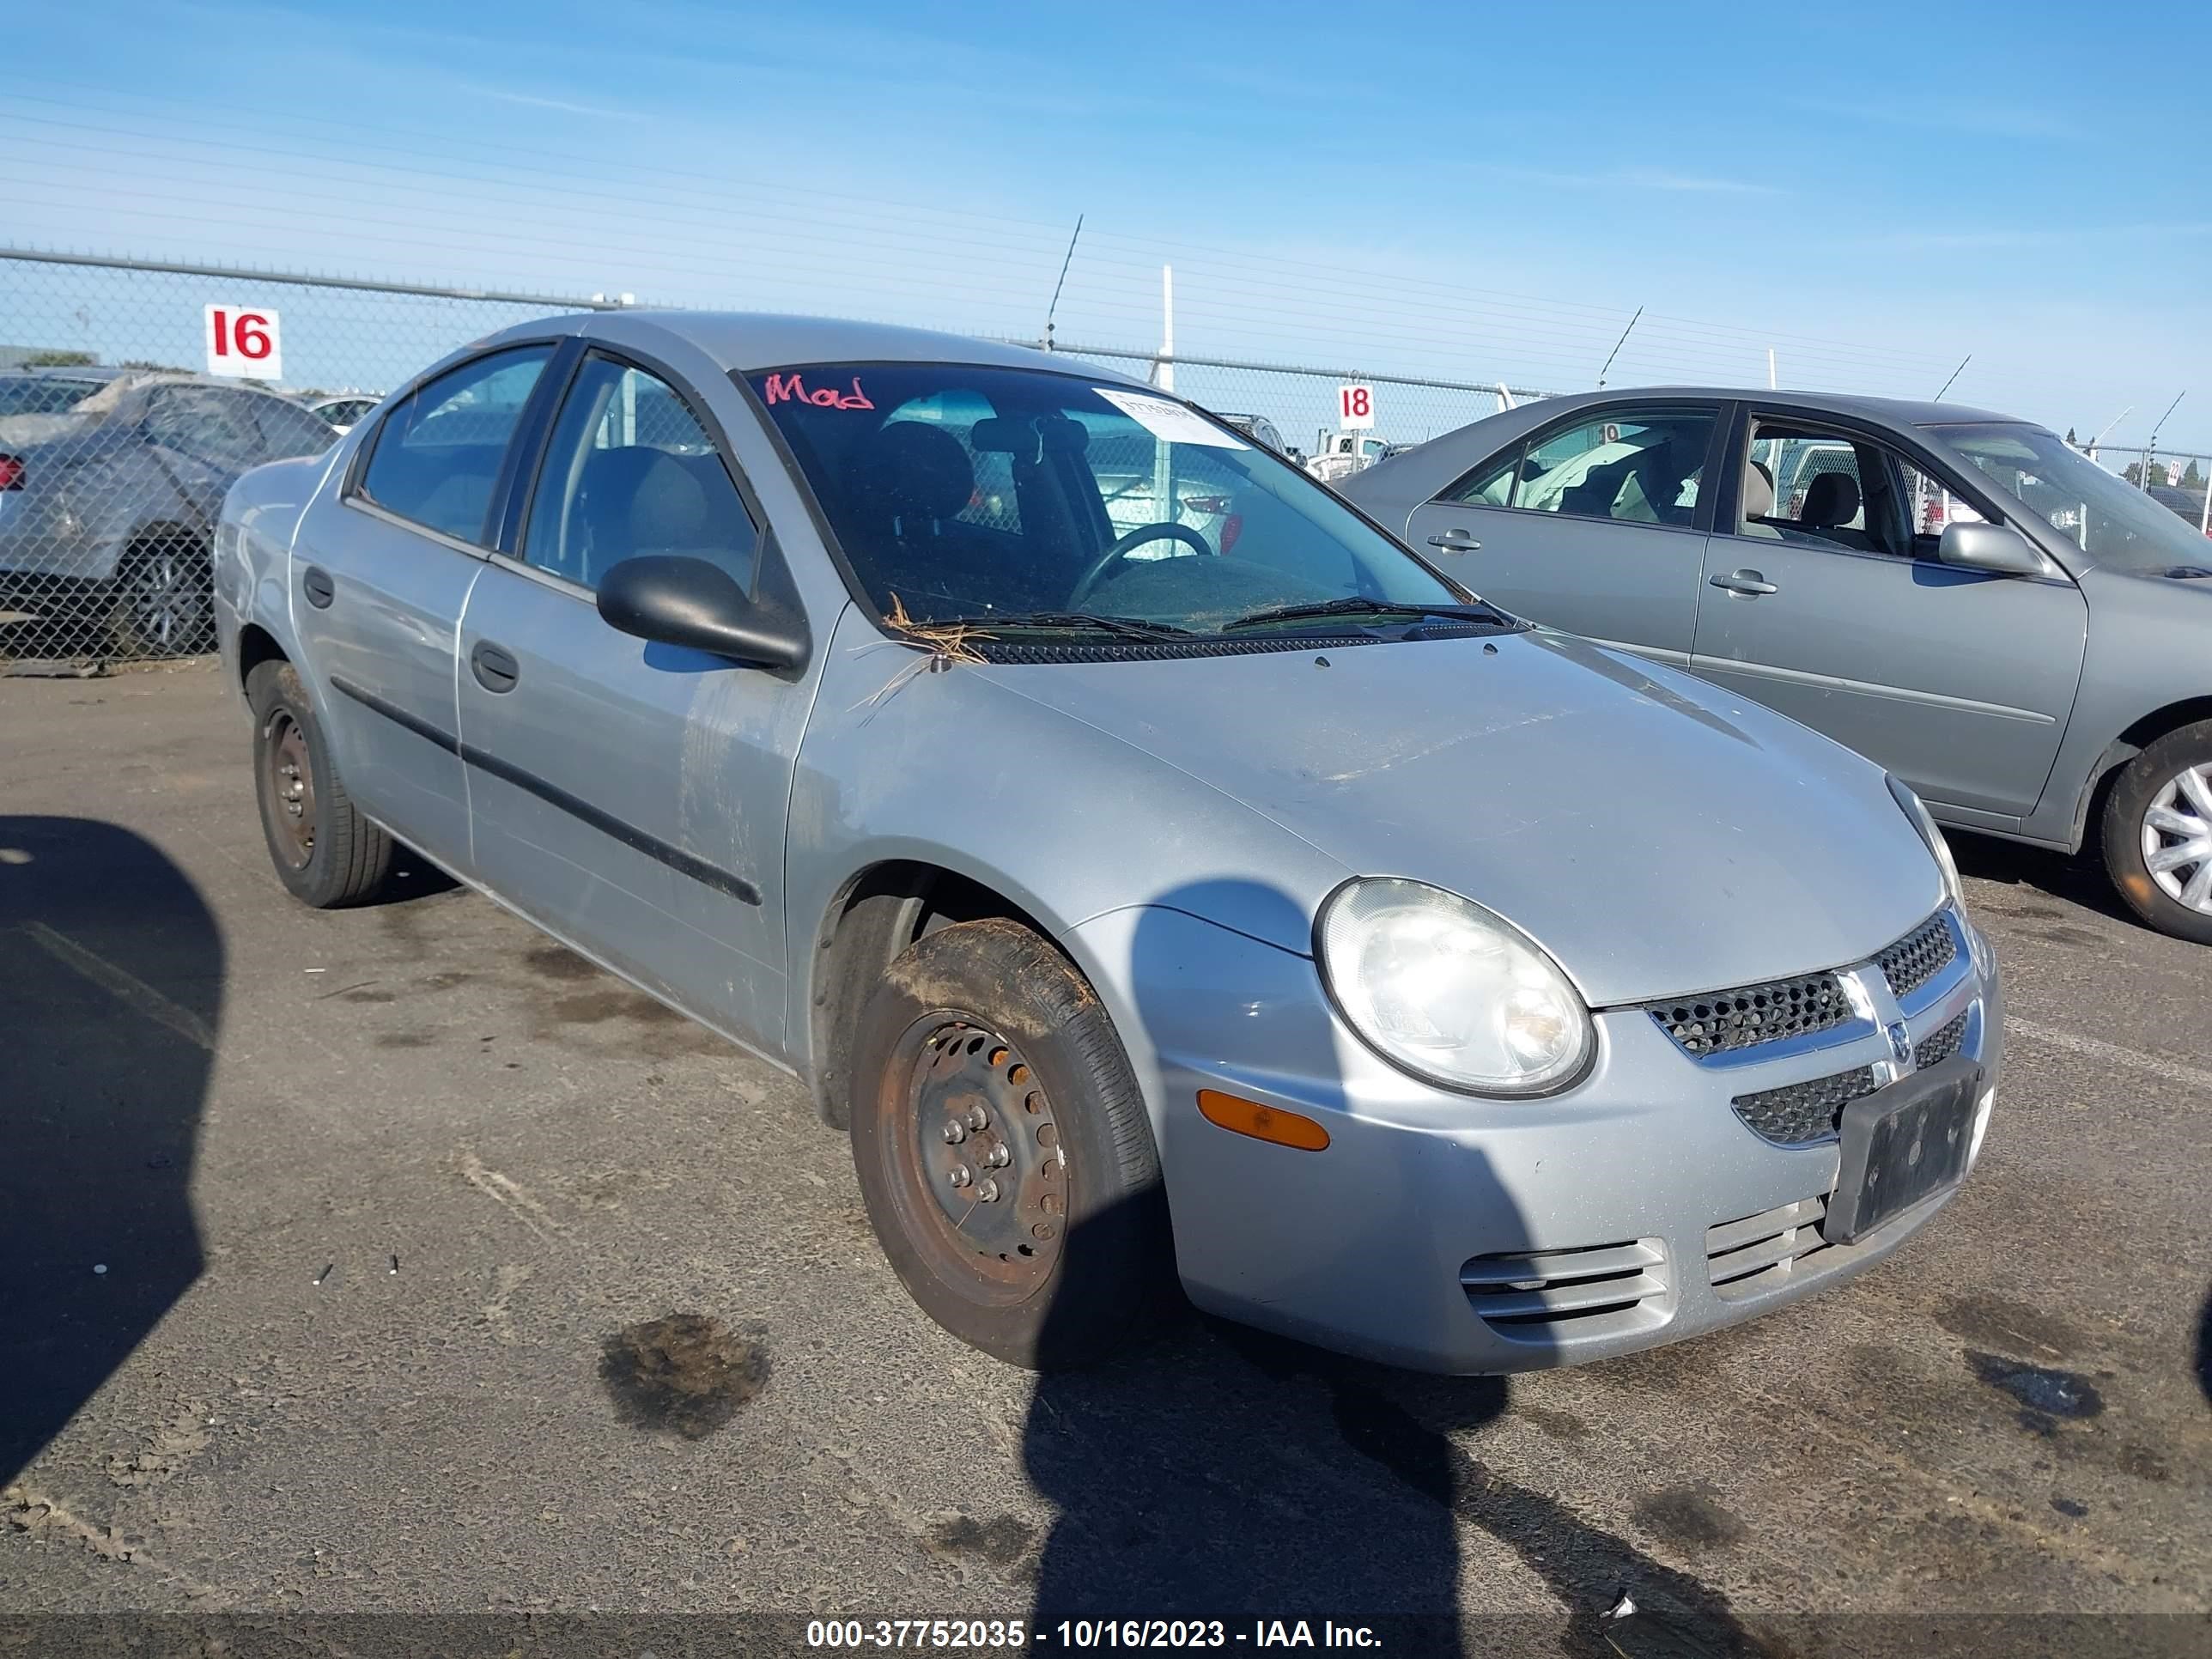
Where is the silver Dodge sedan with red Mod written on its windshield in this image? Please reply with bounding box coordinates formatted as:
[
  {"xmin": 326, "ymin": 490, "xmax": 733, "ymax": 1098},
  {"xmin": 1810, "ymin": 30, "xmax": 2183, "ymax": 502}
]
[{"xmin": 216, "ymin": 312, "xmax": 2002, "ymax": 1371}]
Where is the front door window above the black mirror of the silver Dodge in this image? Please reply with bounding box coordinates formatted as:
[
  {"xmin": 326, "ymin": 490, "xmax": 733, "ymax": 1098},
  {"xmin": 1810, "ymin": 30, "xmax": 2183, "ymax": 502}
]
[{"xmin": 522, "ymin": 354, "xmax": 759, "ymax": 592}]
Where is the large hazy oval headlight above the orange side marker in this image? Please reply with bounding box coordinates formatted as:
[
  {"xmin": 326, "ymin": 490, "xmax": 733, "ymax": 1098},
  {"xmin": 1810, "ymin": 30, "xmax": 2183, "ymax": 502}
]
[{"xmin": 1314, "ymin": 878, "xmax": 1597, "ymax": 1095}]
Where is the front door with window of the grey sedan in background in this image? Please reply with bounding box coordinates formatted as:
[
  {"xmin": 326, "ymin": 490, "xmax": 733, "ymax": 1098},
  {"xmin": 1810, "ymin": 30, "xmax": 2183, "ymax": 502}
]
[{"xmin": 1692, "ymin": 410, "xmax": 2088, "ymax": 827}]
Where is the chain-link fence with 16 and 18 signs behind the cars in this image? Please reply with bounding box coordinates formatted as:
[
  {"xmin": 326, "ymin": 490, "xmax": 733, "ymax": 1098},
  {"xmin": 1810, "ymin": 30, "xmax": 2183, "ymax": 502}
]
[{"xmin": 0, "ymin": 250, "xmax": 1541, "ymax": 672}]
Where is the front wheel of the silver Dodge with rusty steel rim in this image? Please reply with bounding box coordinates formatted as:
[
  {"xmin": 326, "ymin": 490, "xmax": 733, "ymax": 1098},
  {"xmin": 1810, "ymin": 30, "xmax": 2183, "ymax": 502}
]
[{"xmin": 848, "ymin": 918, "xmax": 1172, "ymax": 1371}]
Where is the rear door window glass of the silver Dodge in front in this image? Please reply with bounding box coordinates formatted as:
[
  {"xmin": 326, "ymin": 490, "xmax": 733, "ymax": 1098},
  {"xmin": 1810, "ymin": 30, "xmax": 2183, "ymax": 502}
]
[{"xmin": 361, "ymin": 345, "xmax": 553, "ymax": 542}]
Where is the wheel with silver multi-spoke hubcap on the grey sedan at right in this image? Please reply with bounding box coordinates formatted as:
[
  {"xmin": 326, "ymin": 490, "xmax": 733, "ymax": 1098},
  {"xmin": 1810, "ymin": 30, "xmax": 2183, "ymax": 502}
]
[{"xmin": 2101, "ymin": 721, "xmax": 2212, "ymax": 945}]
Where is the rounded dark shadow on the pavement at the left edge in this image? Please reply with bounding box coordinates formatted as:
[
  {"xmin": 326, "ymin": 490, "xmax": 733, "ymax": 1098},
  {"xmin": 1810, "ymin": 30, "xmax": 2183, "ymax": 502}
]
[{"xmin": 0, "ymin": 817, "xmax": 223, "ymax": 1480}]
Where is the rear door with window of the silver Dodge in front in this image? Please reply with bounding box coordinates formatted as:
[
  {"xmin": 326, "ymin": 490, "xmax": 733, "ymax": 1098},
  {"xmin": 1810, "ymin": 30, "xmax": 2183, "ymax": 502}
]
[{"xmin": 292, "ymin": 343, "xmax": 553, "ymax": 872}]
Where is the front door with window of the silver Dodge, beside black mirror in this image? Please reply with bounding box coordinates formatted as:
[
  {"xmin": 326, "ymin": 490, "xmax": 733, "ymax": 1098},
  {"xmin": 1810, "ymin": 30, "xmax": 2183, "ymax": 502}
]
[{"xmin": 460, "ymin": 349, "xmax": 807, "ymax": 1053}]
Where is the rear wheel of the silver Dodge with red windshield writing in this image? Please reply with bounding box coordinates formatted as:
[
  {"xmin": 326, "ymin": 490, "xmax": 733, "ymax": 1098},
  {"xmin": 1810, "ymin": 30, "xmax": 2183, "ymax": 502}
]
[{"xmin": 246, "ymin": 661, "xmax": 392, "ymax": 909}]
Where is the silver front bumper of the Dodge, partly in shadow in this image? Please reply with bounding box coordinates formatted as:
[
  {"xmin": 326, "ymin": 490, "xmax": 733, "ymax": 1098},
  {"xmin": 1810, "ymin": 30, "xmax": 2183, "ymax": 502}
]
[{"xmin": 1066, "ymin": 907, "xmax": 2004, "ymax": 1374}]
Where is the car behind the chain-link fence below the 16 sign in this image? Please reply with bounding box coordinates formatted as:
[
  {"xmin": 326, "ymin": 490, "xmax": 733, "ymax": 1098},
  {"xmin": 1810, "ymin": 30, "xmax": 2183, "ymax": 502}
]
[{"xmin": 0, "ymin": 368, "xmax": 338, "ymax": 657}]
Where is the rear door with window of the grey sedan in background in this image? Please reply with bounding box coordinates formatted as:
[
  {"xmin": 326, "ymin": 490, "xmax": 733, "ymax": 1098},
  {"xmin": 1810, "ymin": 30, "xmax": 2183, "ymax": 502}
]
[{"xmin": 1407, "ymin": 400, "xmax": 1728, "ymax": 665}]
